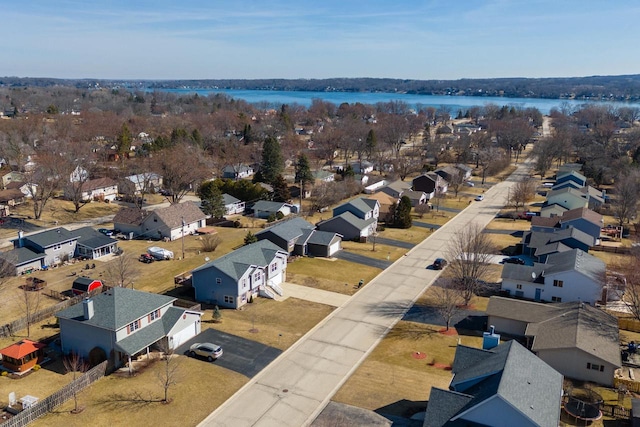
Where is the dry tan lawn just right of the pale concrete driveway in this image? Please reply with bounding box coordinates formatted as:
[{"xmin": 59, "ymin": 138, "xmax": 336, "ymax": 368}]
[{"xmin": 287, "ymin": 258, "xmax": 380, "ymax": 295}]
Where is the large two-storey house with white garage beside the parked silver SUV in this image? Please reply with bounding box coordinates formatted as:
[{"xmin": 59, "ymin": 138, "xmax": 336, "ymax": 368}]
[{"xmin": 56, "ymin": 287, "xmax": 202, "ymax": 367}]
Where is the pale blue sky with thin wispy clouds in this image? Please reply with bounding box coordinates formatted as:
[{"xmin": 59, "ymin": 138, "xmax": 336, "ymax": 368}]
[{"xmin": 0, "ymin": 0, "xmax": 640, "ymax": 80}]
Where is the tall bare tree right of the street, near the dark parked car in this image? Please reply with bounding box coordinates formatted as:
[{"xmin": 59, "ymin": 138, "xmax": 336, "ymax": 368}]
[{"xmin": 447, "ymin": 222, "xmax": 495, "ymax": 305}]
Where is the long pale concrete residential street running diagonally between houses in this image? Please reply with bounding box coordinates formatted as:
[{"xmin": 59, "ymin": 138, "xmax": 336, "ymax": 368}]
[{"xmin": 200, "ymin": 158, "xmax": 532, "ymax": 427}]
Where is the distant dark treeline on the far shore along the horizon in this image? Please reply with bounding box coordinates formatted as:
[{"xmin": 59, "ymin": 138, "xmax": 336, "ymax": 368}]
[{"xmin": 0, "ymin": 74, "xmax": 640, "ymax": 101}]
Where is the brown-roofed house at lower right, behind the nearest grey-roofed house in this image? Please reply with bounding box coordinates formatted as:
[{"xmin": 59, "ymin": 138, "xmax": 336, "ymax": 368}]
[{"xmin": 487, "ymin": 297, "xmax": 621, "ymax": 387}]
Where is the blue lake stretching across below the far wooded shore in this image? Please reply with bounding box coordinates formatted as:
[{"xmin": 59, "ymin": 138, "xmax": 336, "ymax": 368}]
[{"xmin": 151, "ymin": 89, "xmax": 640, "ymax": 116}]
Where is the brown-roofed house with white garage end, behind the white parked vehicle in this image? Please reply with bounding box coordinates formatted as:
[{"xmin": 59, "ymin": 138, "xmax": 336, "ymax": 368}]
[{"xmin": 113, "ymin": 202, "xmax": 206, "ymax": 240}]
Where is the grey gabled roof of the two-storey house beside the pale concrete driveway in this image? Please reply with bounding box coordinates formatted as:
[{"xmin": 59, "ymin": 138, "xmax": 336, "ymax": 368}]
[{"xmin": 192, "ymin": 240, "xmax": 289, "ymax": 280}]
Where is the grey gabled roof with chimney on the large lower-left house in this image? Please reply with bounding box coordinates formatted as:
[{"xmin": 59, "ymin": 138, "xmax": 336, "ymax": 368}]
[{"xmin": 56, "ymin": 287, "xmax": 175, "ymax": 331}]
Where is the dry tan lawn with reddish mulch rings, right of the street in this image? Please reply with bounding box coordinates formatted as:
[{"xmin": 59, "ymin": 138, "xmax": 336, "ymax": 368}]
[{"xmin": 333, "ymin": 321, "xmax": 482, "ymax": 417}]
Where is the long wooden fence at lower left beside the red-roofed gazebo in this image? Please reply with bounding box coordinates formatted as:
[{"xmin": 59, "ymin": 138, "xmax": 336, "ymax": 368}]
[{"xmin": 1, "ymin": 360, "xmax": 108, "ymax": 427}]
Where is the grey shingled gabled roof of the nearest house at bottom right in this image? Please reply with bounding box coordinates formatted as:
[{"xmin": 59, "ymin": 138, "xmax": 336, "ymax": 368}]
[{"xmin": 450, "ymin": 340, "xmax": 563, "ymax": 426}]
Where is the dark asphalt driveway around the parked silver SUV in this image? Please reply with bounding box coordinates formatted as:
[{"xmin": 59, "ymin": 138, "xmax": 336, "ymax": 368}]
[{"xmin": 176, "ymin": 325, "xmax": 282, "ymax": 378}]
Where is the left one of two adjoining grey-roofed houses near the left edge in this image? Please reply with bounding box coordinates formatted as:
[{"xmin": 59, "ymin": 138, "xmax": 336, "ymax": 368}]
[{"xmin": 12, "ymin": 227, "xmax": 78, "ymax": 267}]
